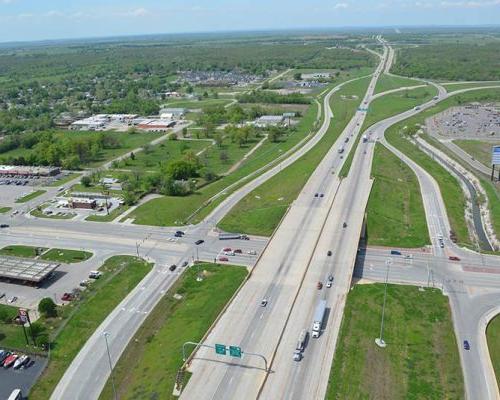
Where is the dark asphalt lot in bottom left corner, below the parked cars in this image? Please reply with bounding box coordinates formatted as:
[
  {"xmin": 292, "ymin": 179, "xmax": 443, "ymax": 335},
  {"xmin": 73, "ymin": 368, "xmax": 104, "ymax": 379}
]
[{"xmin": 0, "ymin": 357, "xmax": 47, "ymax": 400}]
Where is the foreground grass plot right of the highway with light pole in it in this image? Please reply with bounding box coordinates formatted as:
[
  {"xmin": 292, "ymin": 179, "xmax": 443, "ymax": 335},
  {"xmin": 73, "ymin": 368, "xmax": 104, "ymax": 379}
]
[{"xmin": 325, "ymin": 284, "xmax": 464, "ymax": 400}]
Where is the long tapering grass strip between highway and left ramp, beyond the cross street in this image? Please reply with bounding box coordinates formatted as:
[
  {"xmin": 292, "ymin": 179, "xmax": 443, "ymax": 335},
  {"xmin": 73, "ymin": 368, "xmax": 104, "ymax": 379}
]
[{"xmin": 219, "ymin": 77, "xmax": 370, "ymax": 236}]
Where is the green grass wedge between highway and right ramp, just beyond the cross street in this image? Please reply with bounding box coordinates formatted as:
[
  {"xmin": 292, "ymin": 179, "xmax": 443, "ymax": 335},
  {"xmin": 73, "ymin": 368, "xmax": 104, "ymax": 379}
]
[{"xmin": 367, "ymin": 144, "xmax": 430, "ymax": 247}]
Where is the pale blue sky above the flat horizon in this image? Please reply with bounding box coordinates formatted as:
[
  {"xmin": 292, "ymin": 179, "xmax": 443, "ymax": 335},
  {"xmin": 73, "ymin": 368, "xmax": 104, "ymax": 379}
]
[{"xmin": 0, "ymin": 0, "xmax": 500, "ymax": 42}]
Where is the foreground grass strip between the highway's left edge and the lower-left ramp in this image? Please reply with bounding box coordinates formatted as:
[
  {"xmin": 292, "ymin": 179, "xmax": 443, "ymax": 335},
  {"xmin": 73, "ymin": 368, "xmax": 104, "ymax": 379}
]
[{"xmin": 99, "ymin": 264, "xmax": 247, "ymax": 400}]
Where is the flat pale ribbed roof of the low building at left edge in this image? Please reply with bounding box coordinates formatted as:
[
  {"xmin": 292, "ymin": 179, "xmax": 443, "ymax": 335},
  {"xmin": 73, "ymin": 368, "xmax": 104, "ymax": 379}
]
[{"xmin": 0, "ymin": 256, "xmax": 60, "ymax": 282}]
